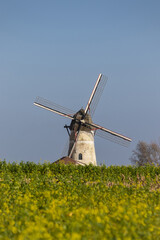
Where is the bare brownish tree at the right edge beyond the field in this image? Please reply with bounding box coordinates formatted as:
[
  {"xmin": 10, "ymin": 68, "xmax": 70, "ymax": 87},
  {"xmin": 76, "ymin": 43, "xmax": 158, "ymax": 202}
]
[{"xmin": 130, "ymin": 141, "xmax": 160, "ymax": 166}]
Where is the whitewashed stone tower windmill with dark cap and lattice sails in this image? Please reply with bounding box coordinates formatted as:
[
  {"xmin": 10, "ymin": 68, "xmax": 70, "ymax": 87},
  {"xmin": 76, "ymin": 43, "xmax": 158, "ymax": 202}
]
[{"xmin": 34, "ymin": 74, "xmax": 131, "ymax": 165}]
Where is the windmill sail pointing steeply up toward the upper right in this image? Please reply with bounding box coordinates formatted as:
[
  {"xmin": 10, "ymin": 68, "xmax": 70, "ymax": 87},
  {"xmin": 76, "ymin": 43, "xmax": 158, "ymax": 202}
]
[{"xmin": 85, "ymin": 74, "xmax": 107, "ymax": 117}]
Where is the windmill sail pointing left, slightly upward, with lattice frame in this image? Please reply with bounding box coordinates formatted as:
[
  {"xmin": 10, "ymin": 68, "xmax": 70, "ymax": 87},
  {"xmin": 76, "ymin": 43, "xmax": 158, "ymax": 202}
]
[{"xmin": 34, "ymin": 97, "xmax": 75, "ymax": 119}]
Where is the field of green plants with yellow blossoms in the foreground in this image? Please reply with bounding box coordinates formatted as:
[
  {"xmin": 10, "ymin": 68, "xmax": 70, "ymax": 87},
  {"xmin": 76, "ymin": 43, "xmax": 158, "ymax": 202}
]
[{"xmin": 0, "ymin": 161, "xmax": 160, "ymax": 240}]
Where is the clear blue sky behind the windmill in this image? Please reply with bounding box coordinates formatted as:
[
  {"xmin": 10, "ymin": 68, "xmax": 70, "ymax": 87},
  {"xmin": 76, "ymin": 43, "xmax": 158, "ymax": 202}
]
[{"xmin": 0, "ymin": 0, "xmax": 160, "ymax": 165}]
